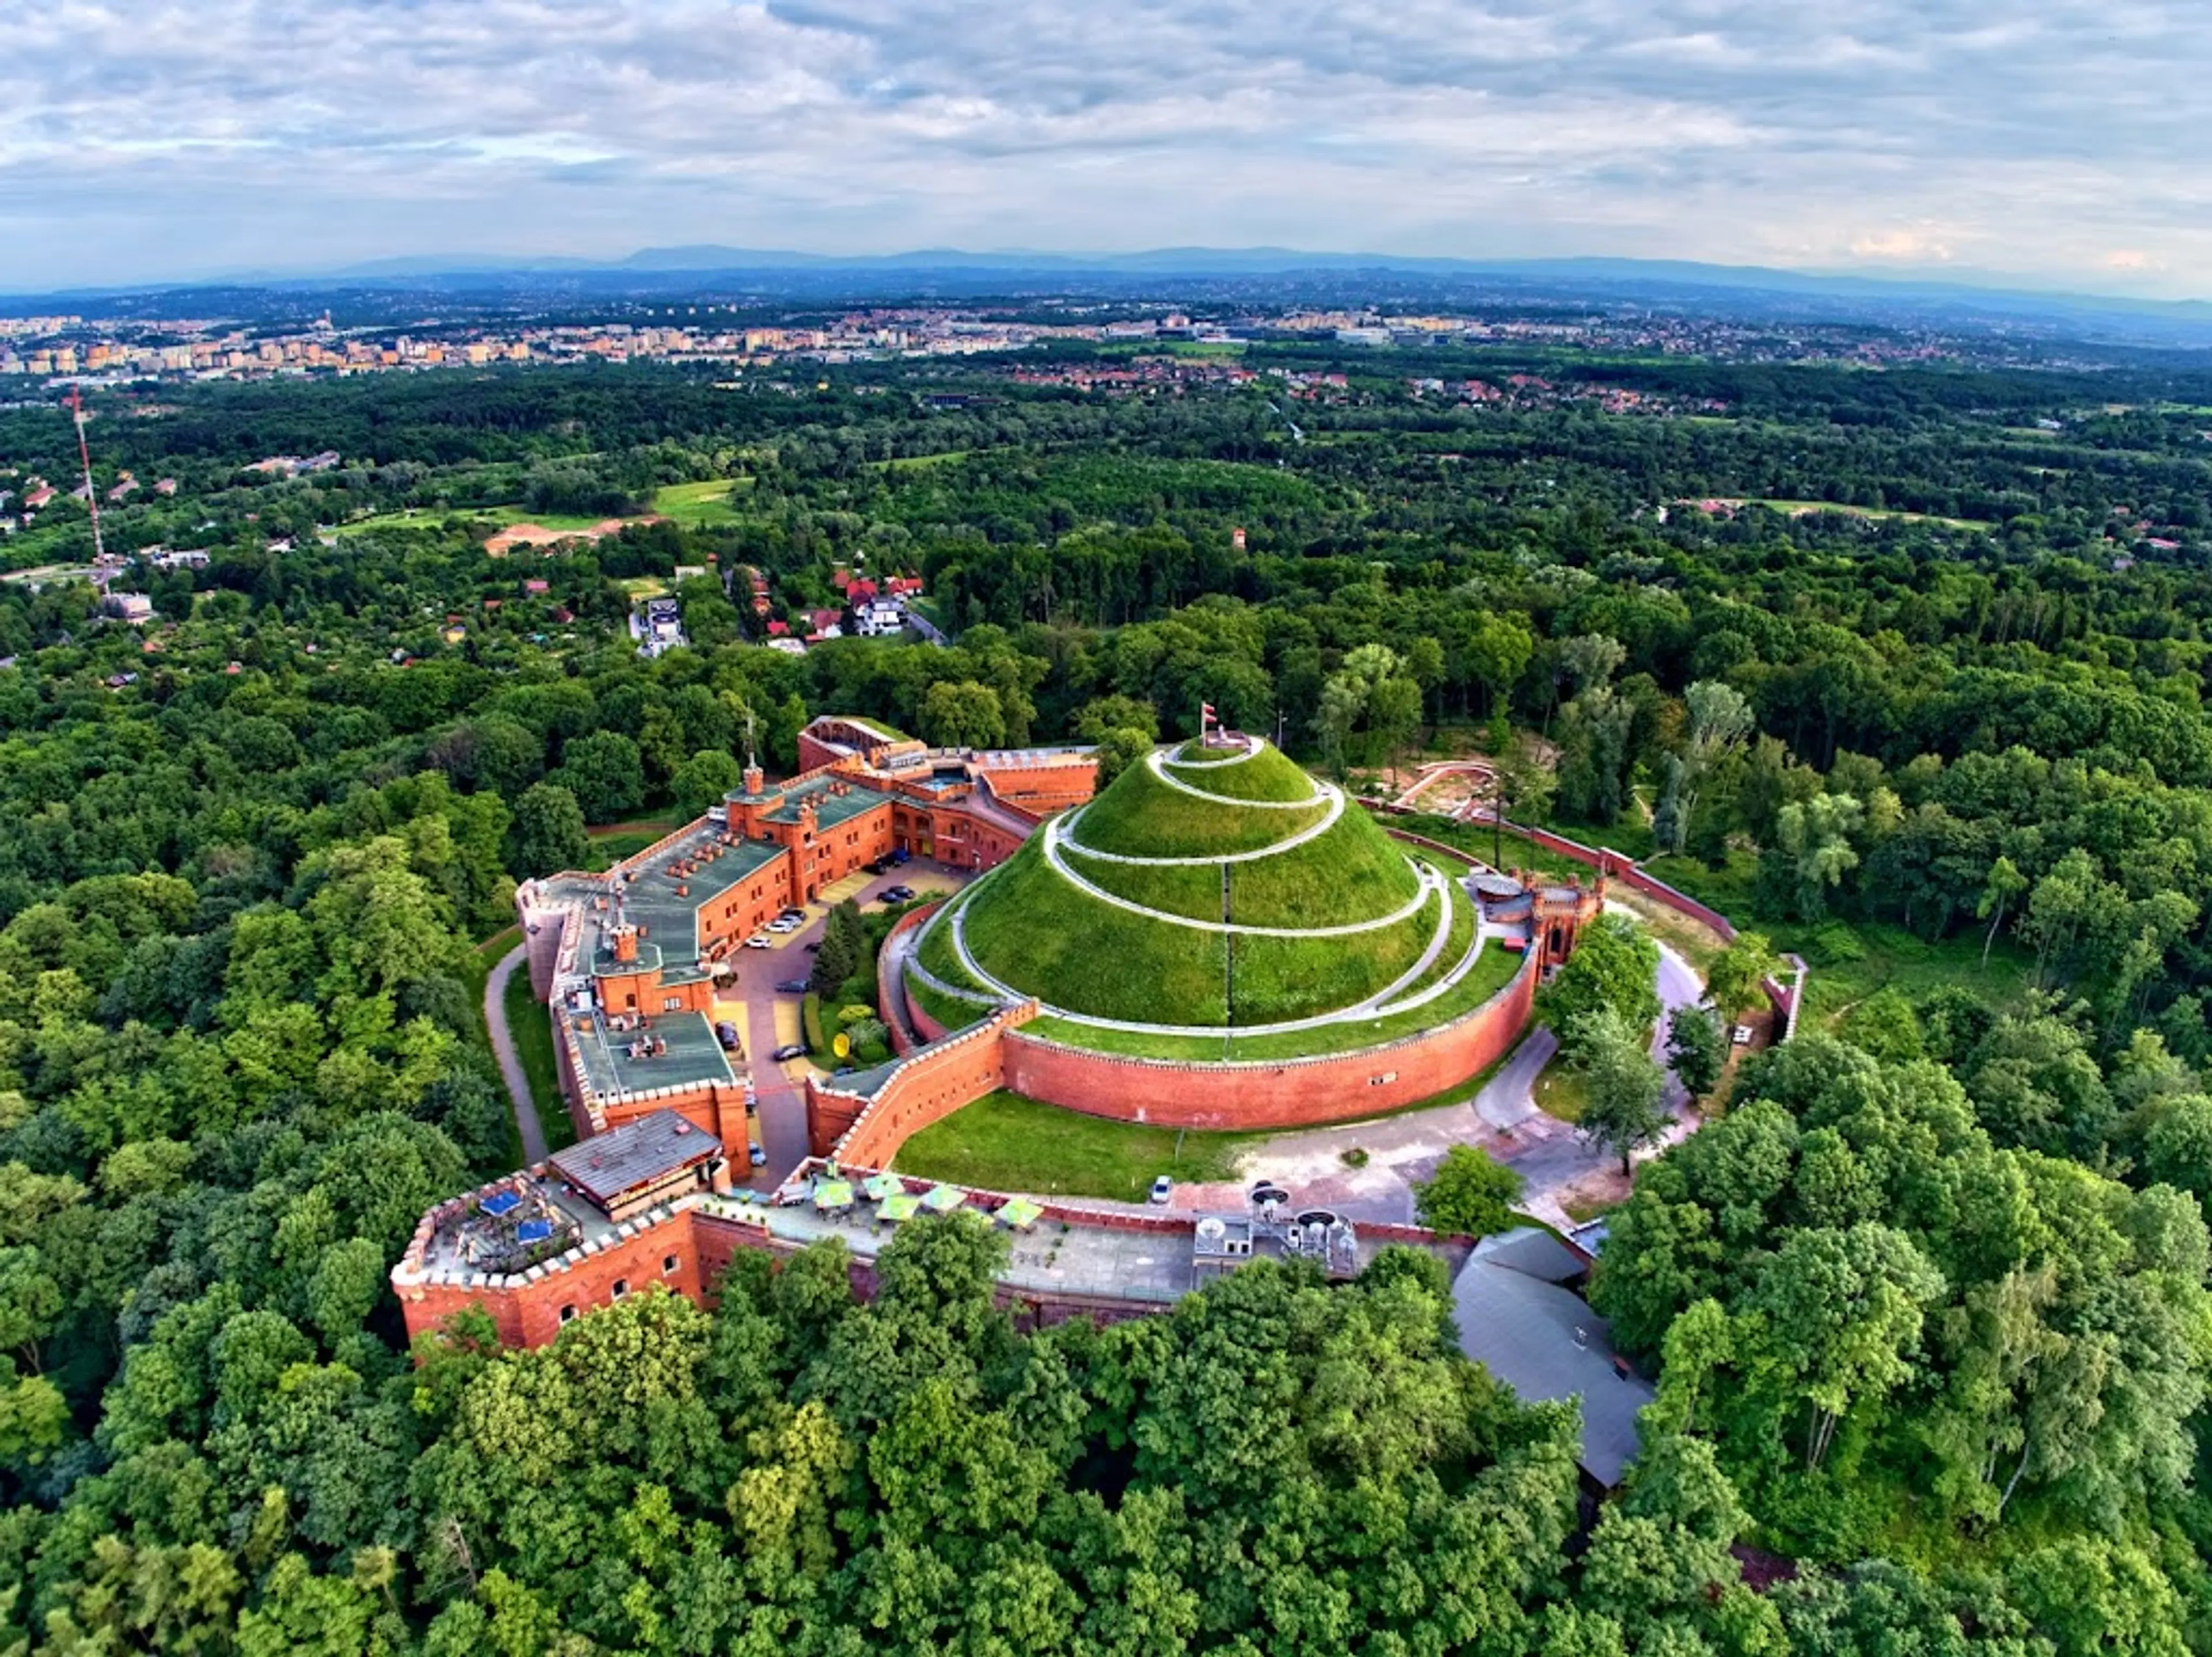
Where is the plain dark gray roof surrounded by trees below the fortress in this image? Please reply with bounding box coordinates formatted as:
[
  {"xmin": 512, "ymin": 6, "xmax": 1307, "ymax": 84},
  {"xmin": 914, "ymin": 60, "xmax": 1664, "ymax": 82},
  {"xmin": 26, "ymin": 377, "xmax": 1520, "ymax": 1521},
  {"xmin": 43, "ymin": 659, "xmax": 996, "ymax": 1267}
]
[{"xmin": 1451, "ymin": 1230, "xmax": 1652, "ymax": 1489}]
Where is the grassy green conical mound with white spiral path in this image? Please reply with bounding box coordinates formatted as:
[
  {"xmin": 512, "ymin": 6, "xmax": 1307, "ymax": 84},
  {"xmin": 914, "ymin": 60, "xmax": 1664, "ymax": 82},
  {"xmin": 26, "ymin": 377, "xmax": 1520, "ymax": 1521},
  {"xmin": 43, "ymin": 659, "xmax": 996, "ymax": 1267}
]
[{"xmin": 946, "ymin": 748, "xmax": 1445, "ymax": 1027}]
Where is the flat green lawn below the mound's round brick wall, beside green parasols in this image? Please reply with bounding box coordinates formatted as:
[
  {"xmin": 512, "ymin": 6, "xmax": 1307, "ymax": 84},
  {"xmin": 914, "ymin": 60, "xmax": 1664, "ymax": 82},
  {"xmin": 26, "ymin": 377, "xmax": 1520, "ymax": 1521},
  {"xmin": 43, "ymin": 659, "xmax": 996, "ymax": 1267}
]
[{"xmin": 896, "ymin": 1091, "xmax": 1261, "ymax": 1201}]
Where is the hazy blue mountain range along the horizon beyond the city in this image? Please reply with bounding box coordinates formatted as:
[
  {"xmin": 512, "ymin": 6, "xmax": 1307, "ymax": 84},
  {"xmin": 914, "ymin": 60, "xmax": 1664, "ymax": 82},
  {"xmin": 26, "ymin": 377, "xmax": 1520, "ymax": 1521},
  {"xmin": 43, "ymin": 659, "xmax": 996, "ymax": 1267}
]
[{"xmin": 9, "ymin": 243, "xmax": 2212, "ymax": 345}]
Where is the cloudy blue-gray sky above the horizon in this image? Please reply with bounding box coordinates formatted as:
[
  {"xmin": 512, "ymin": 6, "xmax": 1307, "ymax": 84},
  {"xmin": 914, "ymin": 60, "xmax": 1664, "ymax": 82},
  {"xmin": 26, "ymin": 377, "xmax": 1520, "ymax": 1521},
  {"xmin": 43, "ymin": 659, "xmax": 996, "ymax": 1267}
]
[{"xmin": 0, "ymin": 0, "xmax": 2212, "ymax": 297}]
